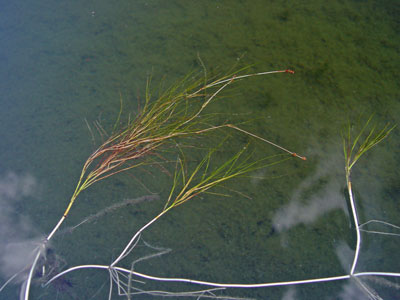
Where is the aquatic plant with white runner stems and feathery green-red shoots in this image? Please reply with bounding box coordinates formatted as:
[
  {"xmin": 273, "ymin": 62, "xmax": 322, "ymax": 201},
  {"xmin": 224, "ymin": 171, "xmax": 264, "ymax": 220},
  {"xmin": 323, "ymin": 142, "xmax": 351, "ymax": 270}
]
[{"xmin": 0, "ymin": 65, "xmax": 400, "ymax": 300}]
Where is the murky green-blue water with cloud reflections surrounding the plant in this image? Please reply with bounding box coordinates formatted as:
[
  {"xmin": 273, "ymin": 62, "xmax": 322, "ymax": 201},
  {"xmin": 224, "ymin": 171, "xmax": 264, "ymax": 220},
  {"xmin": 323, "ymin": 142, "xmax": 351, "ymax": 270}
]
[{"xmin": 0, "ymin": 0, "xmax": 400, "ymax": 299}]
